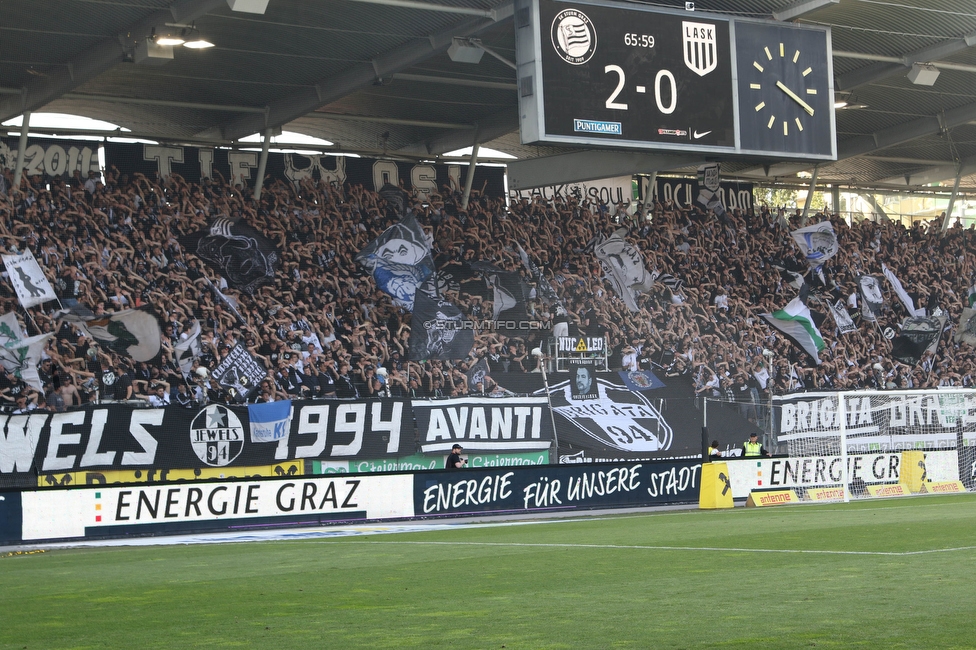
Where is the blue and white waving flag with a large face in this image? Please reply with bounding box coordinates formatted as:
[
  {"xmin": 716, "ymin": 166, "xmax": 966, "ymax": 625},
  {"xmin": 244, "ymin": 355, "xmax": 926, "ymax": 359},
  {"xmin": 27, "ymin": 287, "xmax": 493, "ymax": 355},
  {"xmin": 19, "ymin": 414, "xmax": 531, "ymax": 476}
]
[{"xmin": 356, "ymin": 214, "xmax": 434, "ymax": 310}]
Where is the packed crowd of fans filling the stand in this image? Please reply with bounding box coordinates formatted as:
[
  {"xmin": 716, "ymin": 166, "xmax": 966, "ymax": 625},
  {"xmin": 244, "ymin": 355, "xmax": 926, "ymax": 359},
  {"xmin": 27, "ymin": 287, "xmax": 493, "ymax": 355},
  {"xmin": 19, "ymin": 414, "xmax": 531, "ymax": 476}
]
[{"xmin": 0, "ymin": 162, "xmax": 976, "ymax": 411}]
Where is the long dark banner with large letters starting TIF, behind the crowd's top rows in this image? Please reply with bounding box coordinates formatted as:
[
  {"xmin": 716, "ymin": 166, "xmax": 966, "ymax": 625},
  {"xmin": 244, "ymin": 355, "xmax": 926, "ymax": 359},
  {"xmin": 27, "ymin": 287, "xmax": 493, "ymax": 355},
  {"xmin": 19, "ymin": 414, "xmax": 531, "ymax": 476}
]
[{"xmin": 104, "ymin": 142, "xmax": 505, "ymax": 199}]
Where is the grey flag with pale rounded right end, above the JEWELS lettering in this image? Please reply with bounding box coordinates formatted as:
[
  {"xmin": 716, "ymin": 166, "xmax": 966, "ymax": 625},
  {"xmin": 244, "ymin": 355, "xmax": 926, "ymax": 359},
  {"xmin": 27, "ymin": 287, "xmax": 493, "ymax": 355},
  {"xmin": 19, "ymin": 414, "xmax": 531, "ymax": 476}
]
[{"xmin": 55, "ymin": 306, "xmax": 161, "ymax": 361}]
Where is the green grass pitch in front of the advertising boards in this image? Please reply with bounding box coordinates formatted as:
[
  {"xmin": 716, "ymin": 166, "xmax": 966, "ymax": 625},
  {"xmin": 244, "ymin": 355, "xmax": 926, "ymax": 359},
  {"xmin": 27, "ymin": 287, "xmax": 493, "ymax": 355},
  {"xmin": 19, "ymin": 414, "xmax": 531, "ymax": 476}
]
[{"xmin": 0, "ymin": 495, "xmax": 976, "ymax": 649}]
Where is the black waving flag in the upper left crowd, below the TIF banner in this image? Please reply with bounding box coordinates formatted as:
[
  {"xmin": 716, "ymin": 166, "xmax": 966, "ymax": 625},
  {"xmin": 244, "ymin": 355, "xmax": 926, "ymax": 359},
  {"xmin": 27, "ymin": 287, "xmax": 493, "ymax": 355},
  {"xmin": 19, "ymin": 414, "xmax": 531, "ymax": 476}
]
[{"xmin": 180, "ymin": 218, "xmax": 281, "ymax": 293}]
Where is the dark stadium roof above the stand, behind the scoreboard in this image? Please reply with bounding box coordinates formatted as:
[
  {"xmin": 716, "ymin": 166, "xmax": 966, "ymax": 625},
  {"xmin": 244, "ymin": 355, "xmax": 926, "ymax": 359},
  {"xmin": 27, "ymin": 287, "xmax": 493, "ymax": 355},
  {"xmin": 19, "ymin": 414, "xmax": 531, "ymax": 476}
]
[{"xmin": 0, "ymin": 0, "xmax": 976, "ymax": 191}]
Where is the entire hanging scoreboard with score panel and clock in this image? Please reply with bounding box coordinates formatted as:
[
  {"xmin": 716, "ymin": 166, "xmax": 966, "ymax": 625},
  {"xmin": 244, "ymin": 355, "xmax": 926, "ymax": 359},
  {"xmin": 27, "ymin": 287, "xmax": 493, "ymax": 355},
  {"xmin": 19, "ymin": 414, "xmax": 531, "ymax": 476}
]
[{"xmin": 515, "ymin": 0, "xmax": 837, "ymax": 160}]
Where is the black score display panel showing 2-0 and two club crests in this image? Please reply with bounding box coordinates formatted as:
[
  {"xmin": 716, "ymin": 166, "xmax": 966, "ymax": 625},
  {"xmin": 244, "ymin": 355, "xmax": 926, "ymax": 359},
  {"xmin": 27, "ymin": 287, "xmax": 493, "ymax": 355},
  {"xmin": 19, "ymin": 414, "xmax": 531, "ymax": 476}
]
[{"xmin": 539, "ymin": 0, "xmax": 735, "ymax": 149}]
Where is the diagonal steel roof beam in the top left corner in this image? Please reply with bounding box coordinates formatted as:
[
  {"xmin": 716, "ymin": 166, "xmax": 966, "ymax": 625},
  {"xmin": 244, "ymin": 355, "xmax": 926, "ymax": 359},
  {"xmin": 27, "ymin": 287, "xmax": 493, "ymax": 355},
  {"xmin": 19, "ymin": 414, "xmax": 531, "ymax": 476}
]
[{"xmin": 0, "ymin": 0, "xmax": 227, "ymax": 122}]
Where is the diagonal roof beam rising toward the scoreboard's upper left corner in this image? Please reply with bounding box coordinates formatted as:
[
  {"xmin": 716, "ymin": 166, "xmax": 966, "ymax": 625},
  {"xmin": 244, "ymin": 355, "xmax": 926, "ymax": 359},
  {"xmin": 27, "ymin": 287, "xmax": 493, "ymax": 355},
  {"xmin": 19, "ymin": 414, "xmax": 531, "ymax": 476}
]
[{"xmin": 209, "ymin": 2, "xmax": 513, "ymax": 140}]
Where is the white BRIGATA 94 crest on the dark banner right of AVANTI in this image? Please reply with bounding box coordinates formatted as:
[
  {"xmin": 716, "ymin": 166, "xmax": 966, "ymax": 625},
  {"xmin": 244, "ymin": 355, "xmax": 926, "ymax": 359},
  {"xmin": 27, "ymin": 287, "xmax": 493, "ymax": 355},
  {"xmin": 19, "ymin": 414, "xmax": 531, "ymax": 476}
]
[{"xmin": 550, "ymin": 378, "xmax": 674, "ymax": 453}]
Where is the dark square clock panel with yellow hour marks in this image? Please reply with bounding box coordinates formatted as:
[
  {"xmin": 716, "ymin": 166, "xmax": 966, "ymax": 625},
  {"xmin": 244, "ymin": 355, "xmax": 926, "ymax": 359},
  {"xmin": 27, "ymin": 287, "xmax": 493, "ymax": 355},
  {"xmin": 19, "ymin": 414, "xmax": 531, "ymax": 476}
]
[{"xmin": 736, "ymin": 23, "xmax": 836, "ymax": 158}]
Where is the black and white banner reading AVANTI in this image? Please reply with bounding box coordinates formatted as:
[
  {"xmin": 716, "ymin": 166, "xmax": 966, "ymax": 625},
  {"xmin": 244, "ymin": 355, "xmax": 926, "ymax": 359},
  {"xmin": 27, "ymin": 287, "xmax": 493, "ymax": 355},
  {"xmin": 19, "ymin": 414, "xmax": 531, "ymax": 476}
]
[{"xmin": 412, "ymin": 396, "xmax": 553, "ymax": 454}]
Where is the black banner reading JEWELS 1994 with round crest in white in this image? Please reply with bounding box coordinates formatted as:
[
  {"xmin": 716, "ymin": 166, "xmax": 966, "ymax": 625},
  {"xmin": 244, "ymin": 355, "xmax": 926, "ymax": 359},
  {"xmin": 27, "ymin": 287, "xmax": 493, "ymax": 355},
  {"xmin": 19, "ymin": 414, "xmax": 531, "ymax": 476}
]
[{"xmin": 0, "ymin": 399, "xmax": 415, "ymax": 485}]
